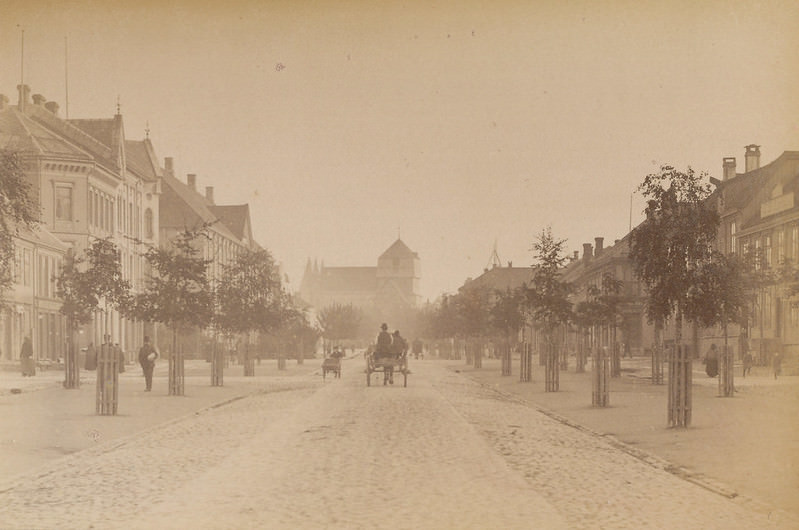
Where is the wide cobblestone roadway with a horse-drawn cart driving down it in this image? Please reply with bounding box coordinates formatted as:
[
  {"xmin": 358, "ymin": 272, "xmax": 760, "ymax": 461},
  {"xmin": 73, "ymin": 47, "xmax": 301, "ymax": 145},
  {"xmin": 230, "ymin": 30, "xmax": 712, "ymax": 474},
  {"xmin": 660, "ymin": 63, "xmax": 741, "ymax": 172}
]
[{"xmin": 0, "ymin": 359, "xmax": 797, "ymax": 529}]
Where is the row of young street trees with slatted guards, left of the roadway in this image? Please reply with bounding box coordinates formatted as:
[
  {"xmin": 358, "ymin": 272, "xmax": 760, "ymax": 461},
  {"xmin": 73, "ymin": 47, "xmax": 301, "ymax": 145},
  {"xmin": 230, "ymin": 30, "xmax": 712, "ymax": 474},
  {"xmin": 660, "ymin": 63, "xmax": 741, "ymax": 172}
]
[{"xmin": 57, "ymin": 226, "xmax": 311, "ymax": 404}]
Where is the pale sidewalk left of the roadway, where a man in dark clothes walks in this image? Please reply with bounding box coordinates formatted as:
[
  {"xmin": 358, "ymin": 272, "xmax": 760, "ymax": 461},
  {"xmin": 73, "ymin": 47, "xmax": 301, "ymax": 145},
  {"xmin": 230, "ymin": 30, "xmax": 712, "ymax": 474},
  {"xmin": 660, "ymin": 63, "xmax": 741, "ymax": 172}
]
[{"xmin": 0, "ymin": 359, "xmax": 321, "ymax": 489}]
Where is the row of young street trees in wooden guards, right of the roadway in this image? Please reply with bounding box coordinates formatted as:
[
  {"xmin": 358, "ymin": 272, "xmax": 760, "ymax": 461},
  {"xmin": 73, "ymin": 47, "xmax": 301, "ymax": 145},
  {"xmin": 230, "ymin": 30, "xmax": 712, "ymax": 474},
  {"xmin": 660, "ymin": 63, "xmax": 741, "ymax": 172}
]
[{"xmin": 427, "ymin": 166, "xmax": 799, "ymax": 427}]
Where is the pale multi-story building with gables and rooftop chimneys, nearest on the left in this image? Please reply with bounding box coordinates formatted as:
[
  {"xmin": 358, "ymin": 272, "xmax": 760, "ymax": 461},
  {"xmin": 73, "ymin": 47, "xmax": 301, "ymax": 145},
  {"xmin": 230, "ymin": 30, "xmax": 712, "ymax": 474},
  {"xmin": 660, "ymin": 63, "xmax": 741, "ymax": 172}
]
[{"xmin": 0, "ymin": 85, "xmax": 160, "ymax": 358}]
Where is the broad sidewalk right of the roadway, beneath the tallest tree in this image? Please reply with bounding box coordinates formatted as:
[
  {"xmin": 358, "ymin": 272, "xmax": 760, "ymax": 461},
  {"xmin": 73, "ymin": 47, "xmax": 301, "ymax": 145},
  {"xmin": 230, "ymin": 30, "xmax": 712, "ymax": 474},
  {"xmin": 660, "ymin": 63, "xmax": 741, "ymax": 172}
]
[{"xmin": 444, "ymin": 357, "xmax": 799, "ymax": 513}]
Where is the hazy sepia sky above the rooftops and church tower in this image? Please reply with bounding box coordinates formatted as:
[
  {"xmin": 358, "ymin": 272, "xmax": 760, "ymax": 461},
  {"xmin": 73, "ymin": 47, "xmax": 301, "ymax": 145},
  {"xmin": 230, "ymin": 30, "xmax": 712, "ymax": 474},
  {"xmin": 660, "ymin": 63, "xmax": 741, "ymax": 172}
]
[{"xmin": 0, "ymin": 0, "xmax": 799, "ymax": 298}]
